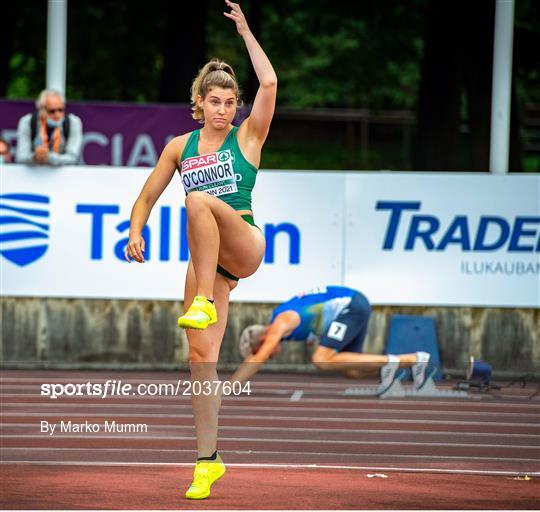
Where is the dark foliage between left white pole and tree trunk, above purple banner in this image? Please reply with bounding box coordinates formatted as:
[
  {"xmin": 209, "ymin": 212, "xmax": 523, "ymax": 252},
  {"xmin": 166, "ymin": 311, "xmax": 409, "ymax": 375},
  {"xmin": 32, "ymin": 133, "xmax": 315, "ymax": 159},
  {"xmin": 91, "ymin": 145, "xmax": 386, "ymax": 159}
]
[{"xmin": 67, "ymin": 0, "xmax": 165, "ymax": 101}]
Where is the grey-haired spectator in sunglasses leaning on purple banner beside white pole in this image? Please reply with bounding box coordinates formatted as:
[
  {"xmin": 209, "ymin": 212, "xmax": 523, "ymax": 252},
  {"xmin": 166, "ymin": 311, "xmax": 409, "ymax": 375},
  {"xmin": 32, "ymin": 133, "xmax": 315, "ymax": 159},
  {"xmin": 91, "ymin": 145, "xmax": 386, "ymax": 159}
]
[{"xmin": 15, "ymin": 89, "xmax": 82, "ymax": 165}]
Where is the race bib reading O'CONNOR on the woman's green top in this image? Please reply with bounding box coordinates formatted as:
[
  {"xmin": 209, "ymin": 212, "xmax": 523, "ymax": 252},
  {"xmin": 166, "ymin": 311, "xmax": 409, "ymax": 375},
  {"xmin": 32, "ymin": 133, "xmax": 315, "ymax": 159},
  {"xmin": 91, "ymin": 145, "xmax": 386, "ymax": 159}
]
[{"xmin": 181, "ymin": 149, "xmax": 238, "ymax": 196}]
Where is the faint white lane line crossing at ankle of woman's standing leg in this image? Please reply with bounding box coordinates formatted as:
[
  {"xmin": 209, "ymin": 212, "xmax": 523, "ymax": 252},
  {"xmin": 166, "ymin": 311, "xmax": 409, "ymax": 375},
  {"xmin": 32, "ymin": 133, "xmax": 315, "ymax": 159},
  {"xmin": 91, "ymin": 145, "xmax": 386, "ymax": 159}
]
[{"xmin": 0, "ymin": 447, "xmax": 538, "ymax": 464}]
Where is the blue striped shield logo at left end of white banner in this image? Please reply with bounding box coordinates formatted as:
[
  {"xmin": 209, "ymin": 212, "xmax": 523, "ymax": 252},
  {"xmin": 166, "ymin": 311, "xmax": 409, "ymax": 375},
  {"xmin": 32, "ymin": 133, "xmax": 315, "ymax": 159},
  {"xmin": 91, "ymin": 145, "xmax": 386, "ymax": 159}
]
[{"xmin": 0, "ymin": 194, "xmax": 50, "ymax": 267}]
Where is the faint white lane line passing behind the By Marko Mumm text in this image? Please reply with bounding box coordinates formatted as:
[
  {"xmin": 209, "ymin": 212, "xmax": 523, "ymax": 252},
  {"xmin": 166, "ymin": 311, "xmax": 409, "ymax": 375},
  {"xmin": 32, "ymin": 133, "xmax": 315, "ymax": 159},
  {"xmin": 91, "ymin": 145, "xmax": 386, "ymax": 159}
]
[{"xmin": 0, "ymin": 423, "xmax": 540, "ymax": 440}]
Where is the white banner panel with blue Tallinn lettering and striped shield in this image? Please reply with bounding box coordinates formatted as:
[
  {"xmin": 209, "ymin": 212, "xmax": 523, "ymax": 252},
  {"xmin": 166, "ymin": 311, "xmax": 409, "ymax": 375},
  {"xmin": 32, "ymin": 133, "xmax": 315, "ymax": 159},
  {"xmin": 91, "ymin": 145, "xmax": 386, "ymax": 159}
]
[{"xmin": 0, "ymin": 165, "xmax": 345, "ymax": 302}]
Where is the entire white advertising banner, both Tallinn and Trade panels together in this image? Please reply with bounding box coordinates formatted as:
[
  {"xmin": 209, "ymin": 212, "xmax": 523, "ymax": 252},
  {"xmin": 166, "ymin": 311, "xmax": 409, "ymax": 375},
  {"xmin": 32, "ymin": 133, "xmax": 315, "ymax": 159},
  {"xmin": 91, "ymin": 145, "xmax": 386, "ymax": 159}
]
[{"xmin": 0, "ymin": 165, "xmax": 540, "ymax": 307}]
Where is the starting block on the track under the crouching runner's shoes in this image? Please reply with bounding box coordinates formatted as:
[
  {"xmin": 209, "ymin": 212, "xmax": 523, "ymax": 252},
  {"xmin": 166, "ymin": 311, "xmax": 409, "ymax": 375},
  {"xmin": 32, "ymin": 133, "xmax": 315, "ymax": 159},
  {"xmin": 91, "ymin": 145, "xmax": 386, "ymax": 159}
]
[{"xmin": 343, "ymin": 367, "xmax": 469, "ymax": 398}]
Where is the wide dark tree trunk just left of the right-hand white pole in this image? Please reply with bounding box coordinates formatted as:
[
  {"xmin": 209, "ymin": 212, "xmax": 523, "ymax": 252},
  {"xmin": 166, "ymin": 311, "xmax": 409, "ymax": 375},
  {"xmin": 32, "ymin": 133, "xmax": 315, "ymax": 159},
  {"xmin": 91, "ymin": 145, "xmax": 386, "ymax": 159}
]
[{"xmin": 413, "ymin": 0, "xmax": 463, "ymax": 171}]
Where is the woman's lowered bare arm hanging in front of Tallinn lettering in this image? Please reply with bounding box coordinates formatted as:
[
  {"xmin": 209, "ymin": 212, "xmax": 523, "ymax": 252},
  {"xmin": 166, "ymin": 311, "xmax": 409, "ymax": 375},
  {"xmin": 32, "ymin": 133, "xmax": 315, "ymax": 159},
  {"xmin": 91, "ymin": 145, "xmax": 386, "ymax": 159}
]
[{"xmin": 125, "ymin": 134, "xmax": 189, "ymax": 263}]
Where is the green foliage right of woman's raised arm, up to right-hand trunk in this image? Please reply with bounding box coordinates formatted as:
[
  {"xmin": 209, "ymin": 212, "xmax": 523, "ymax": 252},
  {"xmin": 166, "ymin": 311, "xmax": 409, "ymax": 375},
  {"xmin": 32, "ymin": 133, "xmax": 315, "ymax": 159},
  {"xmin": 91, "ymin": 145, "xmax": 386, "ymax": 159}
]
[{"xmin": 262, "ymin": 0, "xmax": 425, "ymax": 108}]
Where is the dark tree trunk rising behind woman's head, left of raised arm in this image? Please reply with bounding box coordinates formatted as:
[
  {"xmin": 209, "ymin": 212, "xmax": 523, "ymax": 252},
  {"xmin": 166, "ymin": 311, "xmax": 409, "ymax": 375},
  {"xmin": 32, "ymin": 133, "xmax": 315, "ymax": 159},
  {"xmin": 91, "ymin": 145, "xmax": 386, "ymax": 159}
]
[{"xmin": 158, "ymin": 0, "xmax": 207, "ymax": 103}]
